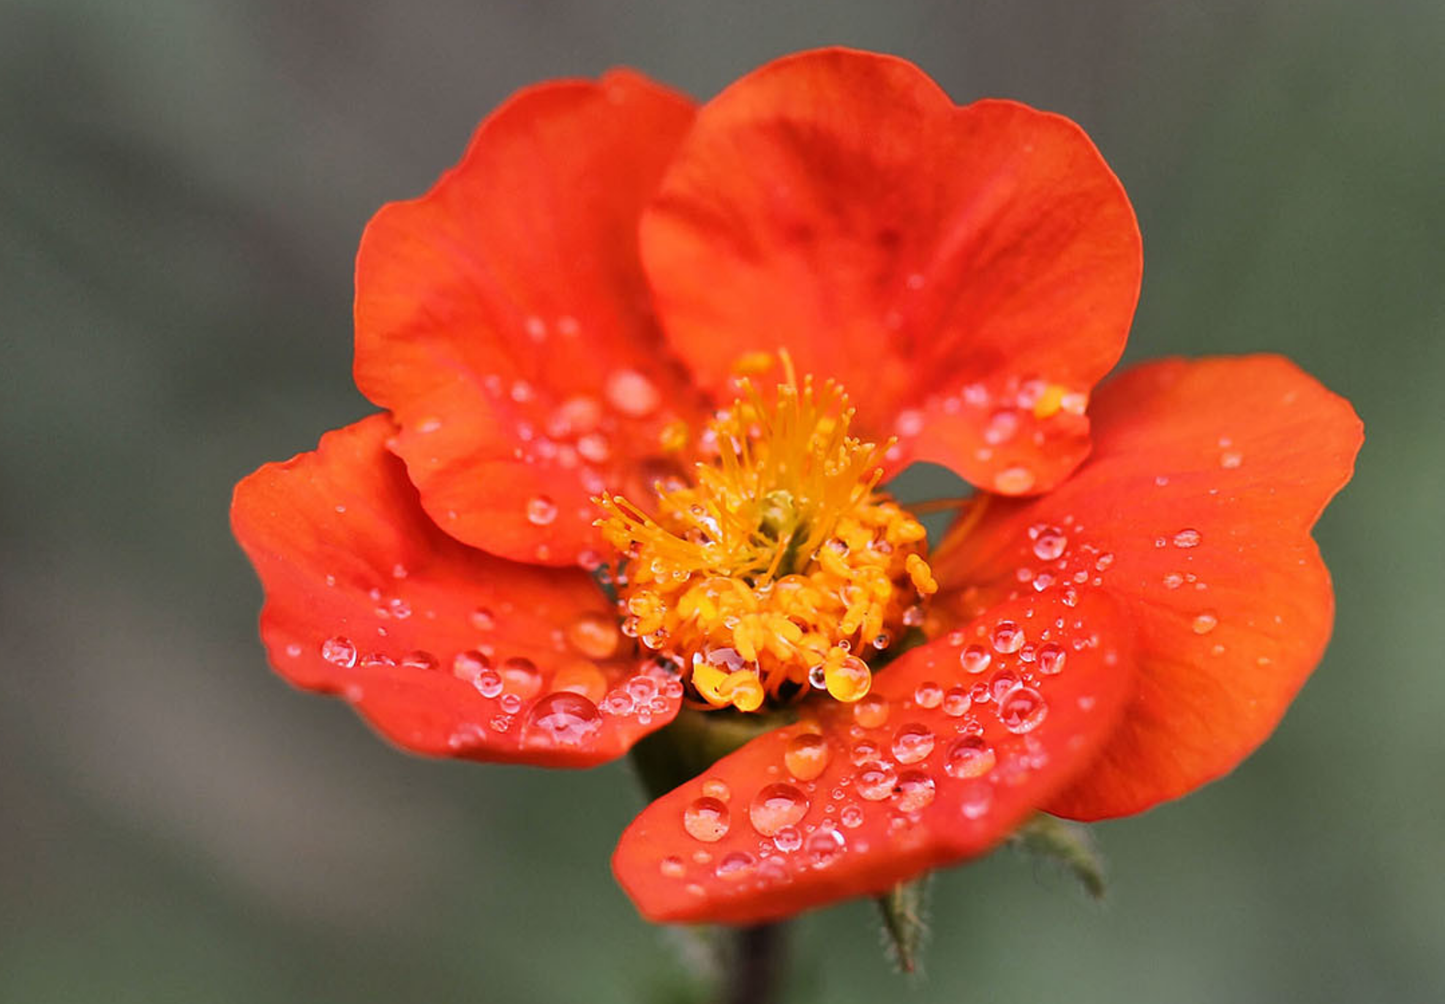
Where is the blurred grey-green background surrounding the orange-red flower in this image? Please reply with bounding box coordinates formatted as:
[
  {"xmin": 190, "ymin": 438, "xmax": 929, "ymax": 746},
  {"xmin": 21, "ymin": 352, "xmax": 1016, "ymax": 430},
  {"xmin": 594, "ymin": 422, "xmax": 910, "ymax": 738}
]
[{"xmin": 0, "ymin": 0, "xmax": 1445, "ymax": 1004}]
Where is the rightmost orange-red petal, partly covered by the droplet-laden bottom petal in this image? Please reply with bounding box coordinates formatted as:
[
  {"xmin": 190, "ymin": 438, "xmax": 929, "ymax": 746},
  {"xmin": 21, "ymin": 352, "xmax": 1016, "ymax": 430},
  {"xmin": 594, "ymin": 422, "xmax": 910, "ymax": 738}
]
[{"xmin": 933, "ymin": 355, "xmax": 1363, "ymax": 819}]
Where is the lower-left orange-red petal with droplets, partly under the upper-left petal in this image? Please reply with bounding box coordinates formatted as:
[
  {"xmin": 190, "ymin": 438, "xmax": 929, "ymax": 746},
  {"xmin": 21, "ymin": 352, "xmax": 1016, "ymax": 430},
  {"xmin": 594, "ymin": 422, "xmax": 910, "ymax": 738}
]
[{"xmin": 231, "ymin": 415, "xmax": 681, "ymax": 767}]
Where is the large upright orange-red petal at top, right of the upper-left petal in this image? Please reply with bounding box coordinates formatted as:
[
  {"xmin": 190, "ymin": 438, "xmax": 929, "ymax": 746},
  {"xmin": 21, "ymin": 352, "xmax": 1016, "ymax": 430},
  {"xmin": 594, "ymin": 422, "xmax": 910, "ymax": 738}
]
[{"xmin": 642, "ymin": 49, "xmax": 1142, "ymax": 494}]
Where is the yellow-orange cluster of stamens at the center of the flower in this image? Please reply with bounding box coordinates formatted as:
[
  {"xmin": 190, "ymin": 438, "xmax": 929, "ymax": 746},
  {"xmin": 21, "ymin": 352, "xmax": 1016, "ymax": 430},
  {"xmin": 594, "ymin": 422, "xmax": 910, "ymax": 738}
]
[{"xmin": 598, "ymin": 355, "xmax": 938, "ymax": 711}]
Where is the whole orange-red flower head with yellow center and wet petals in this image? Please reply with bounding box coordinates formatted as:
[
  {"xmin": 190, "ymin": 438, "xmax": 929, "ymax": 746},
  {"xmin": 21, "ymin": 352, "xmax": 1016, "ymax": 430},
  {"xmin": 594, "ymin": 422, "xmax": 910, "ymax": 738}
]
[{"xmin": 233, "ymin": 49, "xmax": 1361, "ymax": 923}]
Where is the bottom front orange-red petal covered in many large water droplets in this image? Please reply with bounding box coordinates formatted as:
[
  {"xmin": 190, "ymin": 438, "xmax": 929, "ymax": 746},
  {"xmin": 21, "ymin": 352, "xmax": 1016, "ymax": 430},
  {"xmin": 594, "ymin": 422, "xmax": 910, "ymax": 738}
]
[{"xmin": 613, "ymin": 595, "xmax": 1131, "ymax": 923}]
